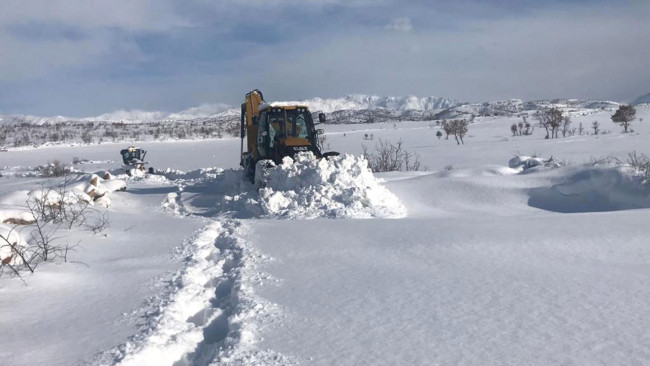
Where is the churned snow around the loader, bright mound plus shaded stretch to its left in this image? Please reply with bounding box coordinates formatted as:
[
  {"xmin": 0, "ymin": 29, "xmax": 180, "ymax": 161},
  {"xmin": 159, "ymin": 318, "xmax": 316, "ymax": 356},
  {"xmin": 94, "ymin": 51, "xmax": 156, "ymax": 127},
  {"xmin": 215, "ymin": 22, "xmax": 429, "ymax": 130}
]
[{"xmin": 162, "ymin": 153, "xmax": 406, "ymax": 219}]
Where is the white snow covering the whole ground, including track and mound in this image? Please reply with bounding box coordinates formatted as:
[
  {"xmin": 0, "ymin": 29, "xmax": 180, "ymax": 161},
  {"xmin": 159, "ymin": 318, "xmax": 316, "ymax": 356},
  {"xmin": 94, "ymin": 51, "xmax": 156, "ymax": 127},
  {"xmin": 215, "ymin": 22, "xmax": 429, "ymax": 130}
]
[{"xmin": 0, "ymin": 106, "xmax": 650, "ymax": 365}]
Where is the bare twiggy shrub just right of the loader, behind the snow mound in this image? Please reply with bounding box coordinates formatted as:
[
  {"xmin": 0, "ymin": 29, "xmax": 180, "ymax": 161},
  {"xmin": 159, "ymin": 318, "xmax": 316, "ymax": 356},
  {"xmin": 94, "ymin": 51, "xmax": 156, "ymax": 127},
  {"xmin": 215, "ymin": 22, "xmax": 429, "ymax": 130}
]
[{"xmin": 361, "ymin": 139, "xmax": 421, "ymax": 172}]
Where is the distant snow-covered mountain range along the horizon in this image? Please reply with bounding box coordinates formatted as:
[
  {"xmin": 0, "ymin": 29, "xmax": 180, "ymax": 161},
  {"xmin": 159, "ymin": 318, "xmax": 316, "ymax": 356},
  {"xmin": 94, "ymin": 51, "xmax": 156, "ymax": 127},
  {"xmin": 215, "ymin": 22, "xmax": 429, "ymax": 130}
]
[{"xmin": 0, "ymin": 94, "xmax": 624, "ymax": 125}]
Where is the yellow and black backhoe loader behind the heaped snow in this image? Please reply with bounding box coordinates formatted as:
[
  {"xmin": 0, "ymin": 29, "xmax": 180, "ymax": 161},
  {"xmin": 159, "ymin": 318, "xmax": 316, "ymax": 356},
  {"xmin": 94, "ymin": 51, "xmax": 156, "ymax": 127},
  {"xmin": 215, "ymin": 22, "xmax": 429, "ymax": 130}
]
[{"xmin": 240, "ymin": 89, "xmax": 339, "ymax": 183}]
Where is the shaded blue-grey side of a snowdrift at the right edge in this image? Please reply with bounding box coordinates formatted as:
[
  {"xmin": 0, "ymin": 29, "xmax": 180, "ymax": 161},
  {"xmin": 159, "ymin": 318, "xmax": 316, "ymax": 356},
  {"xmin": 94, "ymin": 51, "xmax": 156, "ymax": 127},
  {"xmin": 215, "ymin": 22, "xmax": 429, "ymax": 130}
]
[{"xmin": 528, "ymin": 167, "xmax": 650, "ymax": 213}]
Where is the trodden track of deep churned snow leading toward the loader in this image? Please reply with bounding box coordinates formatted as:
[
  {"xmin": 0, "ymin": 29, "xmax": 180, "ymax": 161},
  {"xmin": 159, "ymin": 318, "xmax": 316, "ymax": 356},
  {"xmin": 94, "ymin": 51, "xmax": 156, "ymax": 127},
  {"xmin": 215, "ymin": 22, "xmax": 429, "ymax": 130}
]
[{"xmin": 109, "ymin": 219, "xmax": 290, "ymax": 365}]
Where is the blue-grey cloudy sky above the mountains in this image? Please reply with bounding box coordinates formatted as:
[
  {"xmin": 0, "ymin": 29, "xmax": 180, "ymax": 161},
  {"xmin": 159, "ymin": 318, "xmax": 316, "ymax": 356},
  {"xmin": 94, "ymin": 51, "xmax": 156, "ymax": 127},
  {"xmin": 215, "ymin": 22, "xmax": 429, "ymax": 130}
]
[{"xmin": 0, "ymin": 0, "xmax": 650, "ymax": 116}]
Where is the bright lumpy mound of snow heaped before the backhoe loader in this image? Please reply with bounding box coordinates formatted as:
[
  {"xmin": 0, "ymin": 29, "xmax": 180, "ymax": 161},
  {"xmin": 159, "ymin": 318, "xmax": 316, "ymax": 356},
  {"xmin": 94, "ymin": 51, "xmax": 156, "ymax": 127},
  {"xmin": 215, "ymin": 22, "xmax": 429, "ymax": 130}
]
[{"xmin": 259, "ymin": 153, "xmax": 406, "ymax": 218}]
